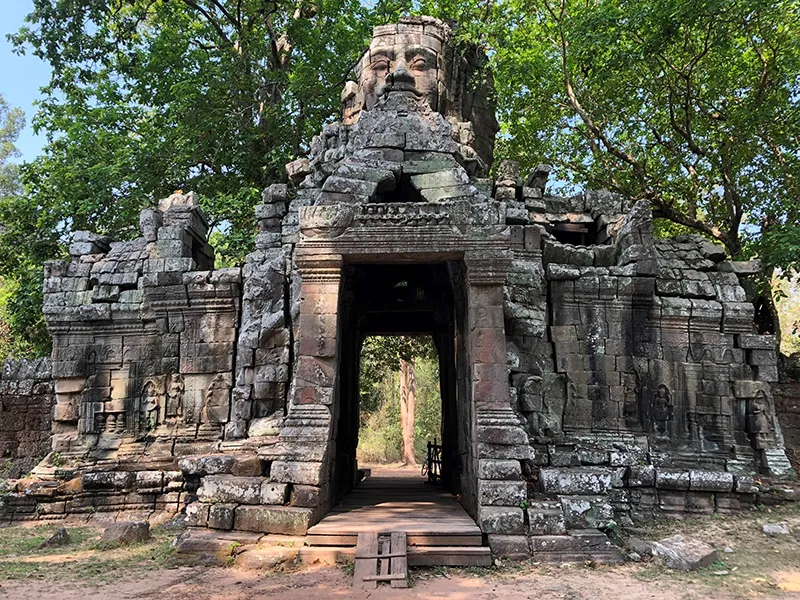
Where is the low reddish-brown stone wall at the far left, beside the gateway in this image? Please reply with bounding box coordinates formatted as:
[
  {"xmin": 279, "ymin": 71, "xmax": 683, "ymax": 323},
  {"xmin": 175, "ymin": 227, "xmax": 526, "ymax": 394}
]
[{"xmin": 0, "ymin": 358, "xmax": 55, "ymax": 479}]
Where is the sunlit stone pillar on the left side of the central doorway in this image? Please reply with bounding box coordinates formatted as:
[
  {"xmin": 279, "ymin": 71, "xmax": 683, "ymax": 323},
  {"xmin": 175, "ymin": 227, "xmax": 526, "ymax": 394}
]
[{"xmin": 262, "ymin": 248, "xmax": 342, "ymax": 520}]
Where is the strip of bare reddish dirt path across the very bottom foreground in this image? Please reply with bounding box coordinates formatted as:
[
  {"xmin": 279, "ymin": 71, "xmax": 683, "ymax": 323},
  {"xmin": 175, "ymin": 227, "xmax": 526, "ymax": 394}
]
[{"xmin": 0, "ymin": 566, "xmax": 788, "ymax": 600}]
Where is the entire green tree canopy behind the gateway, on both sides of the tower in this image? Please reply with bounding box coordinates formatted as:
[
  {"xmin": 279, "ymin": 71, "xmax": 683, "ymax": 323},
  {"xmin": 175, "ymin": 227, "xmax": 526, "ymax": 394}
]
[{"xmin": 0, "ymin": 0, "xmax": 800, "ymax": 356}]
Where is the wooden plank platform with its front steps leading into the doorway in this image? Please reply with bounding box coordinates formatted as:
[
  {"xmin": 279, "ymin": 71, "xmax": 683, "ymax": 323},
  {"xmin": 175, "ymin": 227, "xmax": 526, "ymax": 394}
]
[{"xmin": 304, "ymin": 469, "xmax": 491, "ymax": 566}]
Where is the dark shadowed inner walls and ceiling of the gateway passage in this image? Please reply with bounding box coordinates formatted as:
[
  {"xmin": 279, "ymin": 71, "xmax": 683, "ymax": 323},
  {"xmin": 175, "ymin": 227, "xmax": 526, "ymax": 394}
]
[{"xmin": 333, "ymin": 262, "xmax": 471, "ymax": 502}]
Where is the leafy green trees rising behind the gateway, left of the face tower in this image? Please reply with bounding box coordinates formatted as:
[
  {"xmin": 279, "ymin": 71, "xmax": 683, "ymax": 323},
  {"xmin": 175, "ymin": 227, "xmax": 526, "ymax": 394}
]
[{"xmin": 0, "ymin": 0, "xmax": 412, "ymax": 353}]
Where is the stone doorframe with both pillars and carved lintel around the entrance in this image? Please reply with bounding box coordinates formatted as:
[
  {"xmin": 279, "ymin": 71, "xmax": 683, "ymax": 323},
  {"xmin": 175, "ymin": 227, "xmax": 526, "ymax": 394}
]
[{"xmin": 270, "ymin": 206, "xmax": 530, "ymax": 533}]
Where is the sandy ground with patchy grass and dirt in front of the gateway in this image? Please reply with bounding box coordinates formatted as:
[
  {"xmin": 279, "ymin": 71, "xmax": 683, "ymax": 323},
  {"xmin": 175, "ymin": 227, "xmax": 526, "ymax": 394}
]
[{"xmin": 0, "ymin": 482, "xmax": 800, "ymax": 600}]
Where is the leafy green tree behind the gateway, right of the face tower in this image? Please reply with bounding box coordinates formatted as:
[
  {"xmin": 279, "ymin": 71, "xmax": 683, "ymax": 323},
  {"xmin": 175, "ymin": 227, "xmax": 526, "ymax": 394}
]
[{"xmin": 495, "ymin": 0, "xmax": 800, "ymax": 255}]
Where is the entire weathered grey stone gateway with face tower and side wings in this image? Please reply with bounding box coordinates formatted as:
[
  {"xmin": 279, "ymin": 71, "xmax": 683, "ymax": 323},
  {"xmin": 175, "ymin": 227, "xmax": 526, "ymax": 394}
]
[{"xmin": 2, "ymin": 17, "xmax": 794, "ymax": 560}]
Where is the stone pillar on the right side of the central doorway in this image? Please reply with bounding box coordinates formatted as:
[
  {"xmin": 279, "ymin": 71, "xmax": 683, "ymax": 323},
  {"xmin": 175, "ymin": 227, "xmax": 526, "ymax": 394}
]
[{"xmin": 464, "ymin": 252, "xmax": 532, "ymax": 556}]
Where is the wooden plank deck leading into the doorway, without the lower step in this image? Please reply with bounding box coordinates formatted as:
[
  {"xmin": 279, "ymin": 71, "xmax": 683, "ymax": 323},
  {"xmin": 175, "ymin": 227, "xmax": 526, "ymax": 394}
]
[{"xmin": 308, "ymin": 468, "xmax": 481, "ymax": 546}]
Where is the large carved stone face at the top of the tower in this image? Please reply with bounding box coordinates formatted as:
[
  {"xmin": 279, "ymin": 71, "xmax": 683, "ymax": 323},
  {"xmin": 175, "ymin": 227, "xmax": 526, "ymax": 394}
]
[{"xmin": 359, "ymin": 33, "xmax": 442, "ymax": 110}]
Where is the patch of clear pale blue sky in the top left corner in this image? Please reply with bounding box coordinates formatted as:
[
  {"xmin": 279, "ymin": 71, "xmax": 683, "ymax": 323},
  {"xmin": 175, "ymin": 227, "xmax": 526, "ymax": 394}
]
[{"xmin": 0, "ymin": 0, "xmax": 50, "ymax": 162}]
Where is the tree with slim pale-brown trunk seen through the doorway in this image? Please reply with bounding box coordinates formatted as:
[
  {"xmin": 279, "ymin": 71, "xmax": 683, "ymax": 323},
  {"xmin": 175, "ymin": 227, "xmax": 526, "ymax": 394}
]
[{"xmin": 360, "ymin": 336, "xmax": 436, "ymax": 465}]
